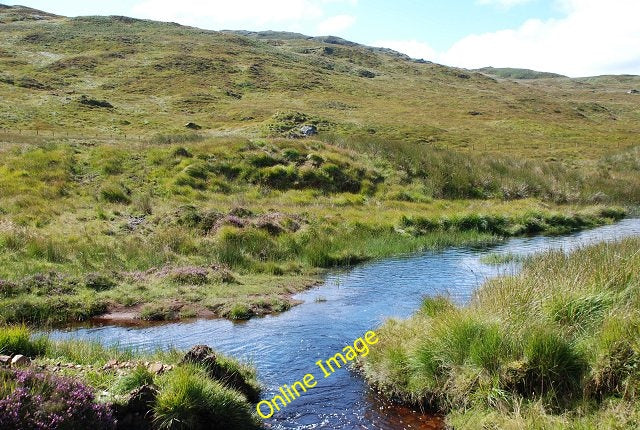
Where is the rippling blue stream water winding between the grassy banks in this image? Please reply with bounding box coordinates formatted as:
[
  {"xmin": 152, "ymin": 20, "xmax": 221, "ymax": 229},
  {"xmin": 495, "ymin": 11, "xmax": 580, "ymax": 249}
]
[{"xmin": 51, "ymin": 219, "xmax": 640, "ymax": 429}]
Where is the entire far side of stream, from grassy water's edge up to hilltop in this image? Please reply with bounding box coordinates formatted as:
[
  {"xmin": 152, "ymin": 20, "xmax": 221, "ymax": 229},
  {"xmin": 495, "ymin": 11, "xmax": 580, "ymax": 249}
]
[{"xmin": 0, "ymin": 6, "xmax": 640, "ymax": 324}]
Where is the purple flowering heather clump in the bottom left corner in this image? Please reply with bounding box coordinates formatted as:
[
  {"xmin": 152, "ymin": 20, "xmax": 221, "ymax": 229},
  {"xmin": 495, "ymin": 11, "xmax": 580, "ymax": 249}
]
[{"xmin": 0, "ymin": 369, "xmax": 115, "ymax": 430}]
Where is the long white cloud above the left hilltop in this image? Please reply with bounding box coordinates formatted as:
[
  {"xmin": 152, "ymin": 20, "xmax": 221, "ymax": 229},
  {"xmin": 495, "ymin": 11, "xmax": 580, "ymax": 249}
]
[{"xmin": 132, "ymin": 0, "xmax": 357, "ymax": 31}]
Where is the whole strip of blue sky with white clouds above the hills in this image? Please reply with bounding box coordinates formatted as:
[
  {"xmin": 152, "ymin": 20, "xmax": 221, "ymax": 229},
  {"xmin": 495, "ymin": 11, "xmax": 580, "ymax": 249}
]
[{"xmin": 7, "ymin": 0, "xmax": 640, "ymax": 77}]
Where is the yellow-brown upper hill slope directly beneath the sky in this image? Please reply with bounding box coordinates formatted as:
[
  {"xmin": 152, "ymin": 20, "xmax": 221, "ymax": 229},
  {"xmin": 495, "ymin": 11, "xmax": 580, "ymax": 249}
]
[{"xmin": 0, "ymin": 3, "xmax": 640, "ymax": 156}]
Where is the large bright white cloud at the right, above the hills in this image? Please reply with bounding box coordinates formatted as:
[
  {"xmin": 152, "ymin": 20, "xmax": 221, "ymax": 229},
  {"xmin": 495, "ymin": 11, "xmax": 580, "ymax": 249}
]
[{"xmin": 380, "ymin": 0, "xmax": 640, "ymax": 77}]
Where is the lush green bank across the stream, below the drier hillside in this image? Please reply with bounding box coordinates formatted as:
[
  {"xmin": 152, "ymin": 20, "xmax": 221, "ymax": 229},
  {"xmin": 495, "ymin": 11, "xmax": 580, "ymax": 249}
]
[{"xmin": 0, "ymin": 135, "xmax": 634, "ymax": 324}]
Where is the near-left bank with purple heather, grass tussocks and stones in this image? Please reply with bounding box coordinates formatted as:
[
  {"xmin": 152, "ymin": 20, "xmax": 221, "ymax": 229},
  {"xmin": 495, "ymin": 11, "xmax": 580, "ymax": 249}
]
[{"xmin": 0, "ymin": 326, "xmax": 260, "ymax": 430}]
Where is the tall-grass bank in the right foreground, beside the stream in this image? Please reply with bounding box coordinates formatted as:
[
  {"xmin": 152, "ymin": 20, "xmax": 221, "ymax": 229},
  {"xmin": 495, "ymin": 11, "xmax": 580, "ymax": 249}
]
[{"xmin": 364, "ymin": 238, "xmax": 640, "ymax": 429}]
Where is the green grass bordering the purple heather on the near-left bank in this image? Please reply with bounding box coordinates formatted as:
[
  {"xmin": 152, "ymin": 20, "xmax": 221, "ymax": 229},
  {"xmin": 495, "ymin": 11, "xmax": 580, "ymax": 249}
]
[{"xmin": 0, "ymin": 326, "xmax": 260, "ymax": 429}]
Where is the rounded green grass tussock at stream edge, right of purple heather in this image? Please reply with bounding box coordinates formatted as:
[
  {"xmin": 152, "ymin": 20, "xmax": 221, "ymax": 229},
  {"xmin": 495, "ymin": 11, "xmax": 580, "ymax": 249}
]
[{"xmin": 154, "ymin": 366, "xmax": 257, "ymax": 430}]
